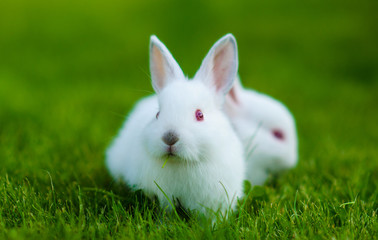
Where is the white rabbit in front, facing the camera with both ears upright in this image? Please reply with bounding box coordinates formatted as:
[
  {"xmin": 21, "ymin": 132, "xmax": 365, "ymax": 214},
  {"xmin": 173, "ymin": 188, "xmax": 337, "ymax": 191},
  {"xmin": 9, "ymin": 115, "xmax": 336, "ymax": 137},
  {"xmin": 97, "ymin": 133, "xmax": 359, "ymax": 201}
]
[{"xmin": 106, "ymin": 34, "xmax": 245, "ymax": 214}]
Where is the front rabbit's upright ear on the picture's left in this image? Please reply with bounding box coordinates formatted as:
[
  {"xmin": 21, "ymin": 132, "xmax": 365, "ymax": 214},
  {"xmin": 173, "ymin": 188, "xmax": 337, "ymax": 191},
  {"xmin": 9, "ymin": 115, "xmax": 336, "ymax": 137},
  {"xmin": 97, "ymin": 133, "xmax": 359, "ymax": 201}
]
[{"xmin": 150, "ymin": 35, "xmax": 184, "ymax": 93}]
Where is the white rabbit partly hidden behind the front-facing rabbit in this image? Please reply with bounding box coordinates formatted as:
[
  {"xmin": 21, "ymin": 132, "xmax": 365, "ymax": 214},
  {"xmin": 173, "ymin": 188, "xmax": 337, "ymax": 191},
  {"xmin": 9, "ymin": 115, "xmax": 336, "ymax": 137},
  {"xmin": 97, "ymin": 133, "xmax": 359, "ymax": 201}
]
[{"xmin": 225, "ymin": 77, "xmax": 298, "ymax": 185}]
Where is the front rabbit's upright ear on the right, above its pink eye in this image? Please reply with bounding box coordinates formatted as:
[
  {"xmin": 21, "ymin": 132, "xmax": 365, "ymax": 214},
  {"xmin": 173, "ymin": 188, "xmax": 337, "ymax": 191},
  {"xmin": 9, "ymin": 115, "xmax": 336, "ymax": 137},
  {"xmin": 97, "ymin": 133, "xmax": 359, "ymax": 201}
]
[{"xmin": 194, "ymin": 34, "xmax": 238, "ymax": 95}]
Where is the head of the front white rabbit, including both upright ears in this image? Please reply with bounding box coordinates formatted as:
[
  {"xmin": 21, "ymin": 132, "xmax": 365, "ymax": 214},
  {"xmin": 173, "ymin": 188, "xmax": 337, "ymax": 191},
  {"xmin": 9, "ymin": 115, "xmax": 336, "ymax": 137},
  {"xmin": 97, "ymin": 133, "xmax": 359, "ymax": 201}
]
[{"xmin": 143, "ymin": 34, "xmax": 238, "ymax": 162}]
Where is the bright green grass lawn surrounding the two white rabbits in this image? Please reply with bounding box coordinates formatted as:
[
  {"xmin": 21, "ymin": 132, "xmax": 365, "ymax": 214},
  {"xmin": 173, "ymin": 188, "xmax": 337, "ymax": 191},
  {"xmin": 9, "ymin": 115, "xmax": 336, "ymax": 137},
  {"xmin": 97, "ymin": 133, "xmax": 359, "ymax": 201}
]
[{"xmin": 0, "ymin": 0, "xmax": 378, "ymax": 239}]
